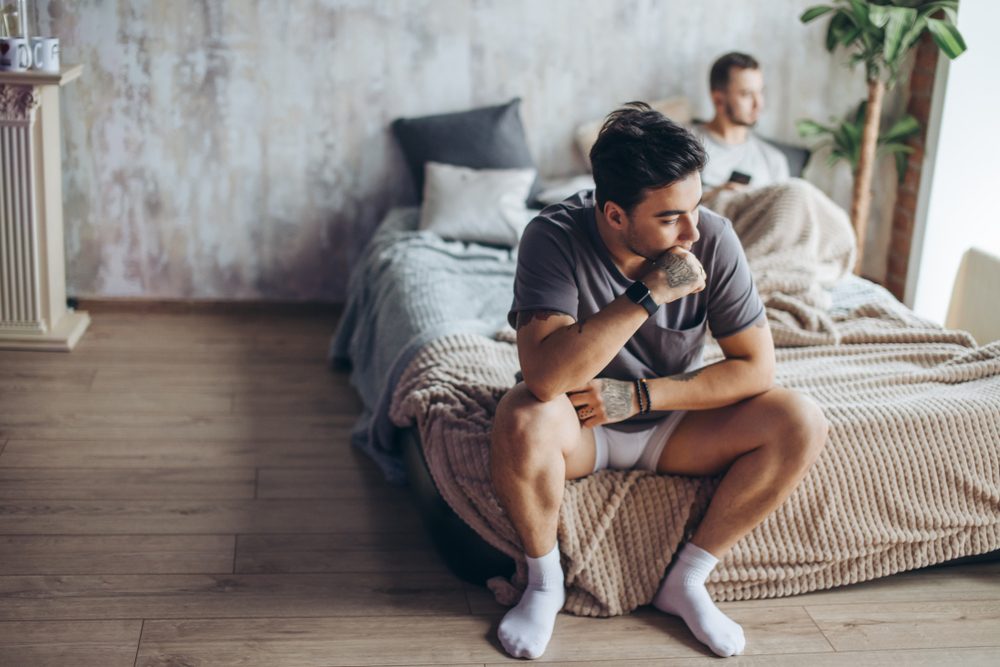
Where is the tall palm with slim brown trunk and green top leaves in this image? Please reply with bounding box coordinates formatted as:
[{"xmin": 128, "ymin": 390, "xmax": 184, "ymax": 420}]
[{"xmin": 800, "ymin": 0, "xmax": 966, "ymax": 272}]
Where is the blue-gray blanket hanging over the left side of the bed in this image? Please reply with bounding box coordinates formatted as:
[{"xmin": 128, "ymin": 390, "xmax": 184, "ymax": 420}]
[{"xmin": 328, "ymin": 208, "xmax": 517, "ymax": 483}]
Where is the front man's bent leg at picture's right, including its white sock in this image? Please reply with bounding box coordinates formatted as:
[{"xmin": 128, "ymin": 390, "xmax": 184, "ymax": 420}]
[{"xmin": 653, "ymin": 389, "xmax": 828, "ymax": 656}]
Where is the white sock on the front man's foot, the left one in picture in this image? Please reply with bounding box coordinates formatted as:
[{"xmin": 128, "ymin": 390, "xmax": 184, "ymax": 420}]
[{"xmin": 497, "ymin": 543, "xmax": 566, "ymax": 658}]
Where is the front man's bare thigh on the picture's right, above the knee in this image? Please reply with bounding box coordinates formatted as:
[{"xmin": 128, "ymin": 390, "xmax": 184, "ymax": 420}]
[{"xmin": 656, "ymin": 388, "xmax": 801, "ymax": 476}]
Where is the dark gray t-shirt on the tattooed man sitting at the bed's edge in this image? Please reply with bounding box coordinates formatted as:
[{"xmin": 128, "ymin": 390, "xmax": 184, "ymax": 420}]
[{"xmin": 507, "ymin": 190, "xmax": 764, "ymax": 426}]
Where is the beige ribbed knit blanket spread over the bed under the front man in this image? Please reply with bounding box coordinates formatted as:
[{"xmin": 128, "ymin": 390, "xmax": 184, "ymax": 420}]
[{"xmin": 390, "ymin": 185, "xmax": 1000, "ymax": 616}]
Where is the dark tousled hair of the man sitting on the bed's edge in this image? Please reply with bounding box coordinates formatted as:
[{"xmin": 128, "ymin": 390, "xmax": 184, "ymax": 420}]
[{"xmin": 590, "ymin": 102, "xmax": 707, "ymax": 214}]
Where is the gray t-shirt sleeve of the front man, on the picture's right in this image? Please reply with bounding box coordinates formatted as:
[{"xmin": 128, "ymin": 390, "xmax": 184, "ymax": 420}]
[{"xmin": 708, "ymin": 220, "xmax": 764, "ymax": 339}]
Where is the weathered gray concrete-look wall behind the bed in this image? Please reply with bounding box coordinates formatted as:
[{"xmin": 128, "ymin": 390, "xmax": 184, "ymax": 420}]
[{"xmin": 36, "ymin": 0, "xmax": 901, "ymax": 301}]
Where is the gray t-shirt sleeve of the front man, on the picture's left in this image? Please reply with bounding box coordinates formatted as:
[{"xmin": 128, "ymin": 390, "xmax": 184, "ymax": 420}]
[{"xmin": 507, "ymin": 219, "xmax": 580, "ymax": 327}]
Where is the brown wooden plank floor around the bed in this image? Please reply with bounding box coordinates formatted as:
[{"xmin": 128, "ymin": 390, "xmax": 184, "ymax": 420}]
[{"xmin": 0, "ymin": 309, "xmax": 1000, "ymax": 667}]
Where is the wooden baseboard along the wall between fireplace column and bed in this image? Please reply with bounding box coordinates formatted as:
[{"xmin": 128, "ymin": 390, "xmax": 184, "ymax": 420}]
[{"xmin": 68, "ymin": 297, "xmax": 344, "ymax": 317}]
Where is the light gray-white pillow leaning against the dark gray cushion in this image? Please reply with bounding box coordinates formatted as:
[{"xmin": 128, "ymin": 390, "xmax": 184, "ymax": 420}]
[{"xmin": 420, "ymin": 162, "xmax": 536, "ymax": 247}]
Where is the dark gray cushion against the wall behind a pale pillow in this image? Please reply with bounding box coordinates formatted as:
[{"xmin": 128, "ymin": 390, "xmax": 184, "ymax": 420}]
[{"xmin": 392, "ymin": 97, "xmax": 541, "ymax": 203}]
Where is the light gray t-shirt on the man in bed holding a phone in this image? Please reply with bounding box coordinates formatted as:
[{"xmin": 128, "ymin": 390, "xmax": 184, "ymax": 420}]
[{"xmin": 690, "ymin": 123, "xmax": 790, "ymax": 188}]
